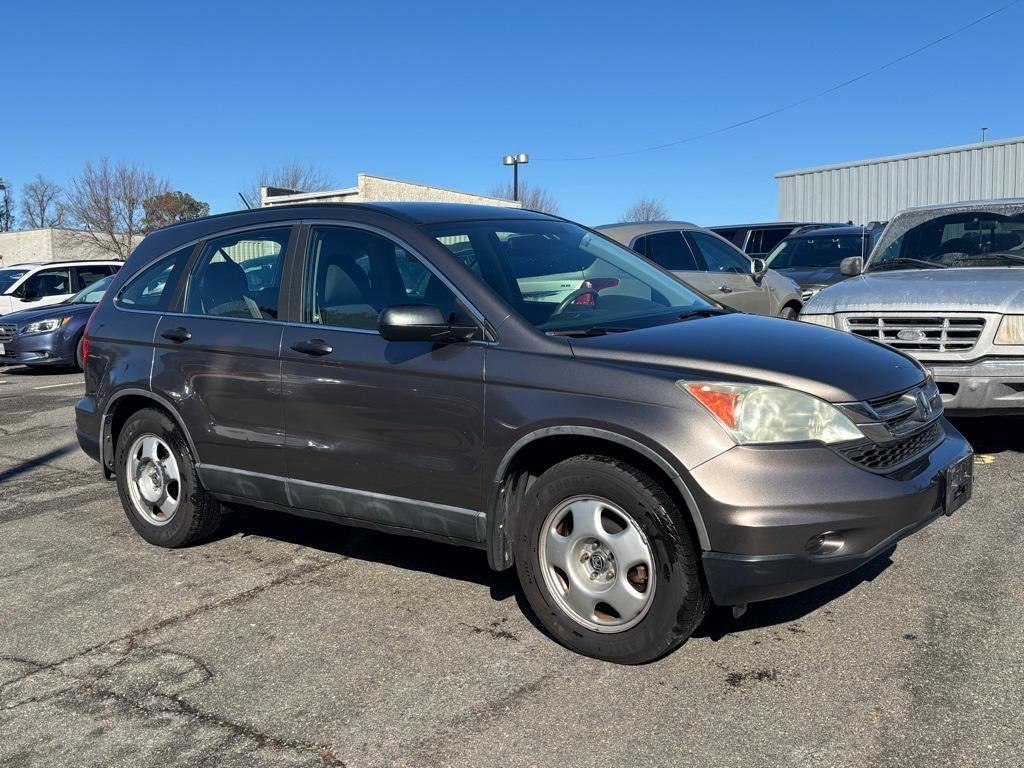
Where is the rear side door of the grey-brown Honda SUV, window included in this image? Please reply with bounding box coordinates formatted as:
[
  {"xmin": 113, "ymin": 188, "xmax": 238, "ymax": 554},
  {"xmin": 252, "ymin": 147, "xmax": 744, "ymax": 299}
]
[{"xmin": 152, "ymin": 224, "xmax": 294, "ymax": 504}]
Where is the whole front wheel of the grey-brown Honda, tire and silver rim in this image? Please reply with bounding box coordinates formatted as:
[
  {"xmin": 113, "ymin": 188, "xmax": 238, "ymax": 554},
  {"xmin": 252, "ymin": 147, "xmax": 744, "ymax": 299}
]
[{"xmin": 516, "ymin": 456, "xmax": 709, "ymax": 664}]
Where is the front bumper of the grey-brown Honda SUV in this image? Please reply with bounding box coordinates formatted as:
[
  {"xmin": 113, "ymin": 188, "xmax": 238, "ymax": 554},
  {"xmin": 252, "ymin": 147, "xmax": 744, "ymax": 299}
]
[{"xmin": 692, "ymin": 419, "xmax": 972, "ymax": 605}]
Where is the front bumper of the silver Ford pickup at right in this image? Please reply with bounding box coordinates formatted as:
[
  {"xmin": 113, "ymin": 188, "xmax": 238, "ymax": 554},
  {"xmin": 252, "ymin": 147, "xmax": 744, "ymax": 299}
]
[{"xmin": 919, "ymin": 358, "xmax": 1024, "ymax": 416}]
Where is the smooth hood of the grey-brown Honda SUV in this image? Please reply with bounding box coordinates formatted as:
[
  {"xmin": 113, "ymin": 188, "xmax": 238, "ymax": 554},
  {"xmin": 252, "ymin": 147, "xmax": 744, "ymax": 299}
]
[{"xmin": 569, "ymin": 312, "xmax": 925, "ymax": 402}]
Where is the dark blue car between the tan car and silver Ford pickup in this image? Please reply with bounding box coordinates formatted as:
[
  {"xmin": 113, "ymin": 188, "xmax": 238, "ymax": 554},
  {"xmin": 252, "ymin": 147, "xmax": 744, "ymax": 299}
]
[{"xmin": 767, "ymin": 221, "xmax": 885, "ymax": 302}]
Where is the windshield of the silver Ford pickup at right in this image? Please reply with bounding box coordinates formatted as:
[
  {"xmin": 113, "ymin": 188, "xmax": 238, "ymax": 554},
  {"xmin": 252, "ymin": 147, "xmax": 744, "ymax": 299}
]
[{"xmin": 868, "ymin": 210, "xmax": 1024, "ymax": 271}]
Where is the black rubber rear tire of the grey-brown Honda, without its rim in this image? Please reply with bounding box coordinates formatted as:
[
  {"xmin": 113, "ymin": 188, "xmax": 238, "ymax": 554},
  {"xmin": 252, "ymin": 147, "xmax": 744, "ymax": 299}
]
[{"xmin": 115, "ymin": 409, "xmax": 223, "ymax": 548}]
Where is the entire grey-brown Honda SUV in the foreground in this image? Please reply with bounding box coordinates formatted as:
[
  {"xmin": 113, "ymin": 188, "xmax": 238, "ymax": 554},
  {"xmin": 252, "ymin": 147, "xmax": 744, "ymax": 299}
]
[{"xmin": 76, "ymin": 203, "xmax": 972, "ymax": 663}]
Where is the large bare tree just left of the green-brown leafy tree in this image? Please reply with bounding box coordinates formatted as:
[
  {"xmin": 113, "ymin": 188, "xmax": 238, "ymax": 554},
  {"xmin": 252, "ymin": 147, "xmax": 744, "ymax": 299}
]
[{"xmin": 67, "ymin": 158, "xmax": 169, "ymax": 259}]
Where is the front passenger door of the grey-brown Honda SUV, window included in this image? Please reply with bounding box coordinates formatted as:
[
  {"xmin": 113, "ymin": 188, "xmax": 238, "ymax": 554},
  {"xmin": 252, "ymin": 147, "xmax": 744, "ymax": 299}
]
[{"xmin": 281, "ymin": 226, "xmax": 486, "ymax": 541}]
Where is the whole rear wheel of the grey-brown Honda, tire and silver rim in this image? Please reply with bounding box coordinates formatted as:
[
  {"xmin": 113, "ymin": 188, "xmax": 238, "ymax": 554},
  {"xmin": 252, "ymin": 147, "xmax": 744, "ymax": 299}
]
[{"xmin": 115, "ymin": 409, "xmax": 222, "ymax": 547}]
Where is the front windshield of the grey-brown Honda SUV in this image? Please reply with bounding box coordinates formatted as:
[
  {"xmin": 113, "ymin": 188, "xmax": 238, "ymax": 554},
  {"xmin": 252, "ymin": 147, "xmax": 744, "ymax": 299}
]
[{"xmin": 427, "ymin": 219, "xmax": 720, "ymax": 333}]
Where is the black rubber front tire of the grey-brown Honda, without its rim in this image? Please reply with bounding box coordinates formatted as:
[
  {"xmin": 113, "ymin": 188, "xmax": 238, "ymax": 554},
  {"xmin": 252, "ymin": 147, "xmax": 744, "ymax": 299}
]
[{"xmin": 516, "ymin": 456, "xmax": 710, "ymax": 664}]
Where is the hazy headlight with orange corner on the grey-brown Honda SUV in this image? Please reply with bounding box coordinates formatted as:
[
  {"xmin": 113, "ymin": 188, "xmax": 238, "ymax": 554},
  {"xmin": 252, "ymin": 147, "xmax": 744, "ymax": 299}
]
[{"xmin": 676, "ymin": 381, "xmax": 864, "ymax": 443}]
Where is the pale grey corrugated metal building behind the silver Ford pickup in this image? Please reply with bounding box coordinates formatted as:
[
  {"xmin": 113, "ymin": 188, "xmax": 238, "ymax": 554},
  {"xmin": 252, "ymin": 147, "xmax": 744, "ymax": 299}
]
[{"xmin": 775, "ymin": 136, "xmax": 1024, "ymax": 224}]
